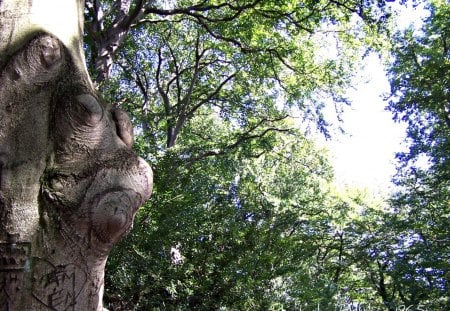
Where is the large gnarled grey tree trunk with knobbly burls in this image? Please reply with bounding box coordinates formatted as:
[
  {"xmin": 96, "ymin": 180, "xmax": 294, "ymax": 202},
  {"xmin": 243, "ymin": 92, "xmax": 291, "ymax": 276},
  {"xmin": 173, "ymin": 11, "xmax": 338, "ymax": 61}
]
[{"xmin": 0, "ymin": 0, "xmax": 152, "ymax": 311}]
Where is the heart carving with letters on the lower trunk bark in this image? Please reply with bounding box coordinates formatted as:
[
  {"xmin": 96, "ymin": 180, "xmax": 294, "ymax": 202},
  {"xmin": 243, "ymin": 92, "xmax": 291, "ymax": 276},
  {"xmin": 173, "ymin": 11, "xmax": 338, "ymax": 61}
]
[{"xmin": 32, "ymin": 258, "xmax": 87, "ymax": 311}]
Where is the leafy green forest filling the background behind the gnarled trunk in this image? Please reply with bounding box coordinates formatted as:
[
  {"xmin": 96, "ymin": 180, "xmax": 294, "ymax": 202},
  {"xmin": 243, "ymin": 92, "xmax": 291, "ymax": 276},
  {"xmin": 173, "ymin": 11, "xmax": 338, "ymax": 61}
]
[{"xmin": 79, "ymin": 0, "xmax": 450, "ymax": 310}]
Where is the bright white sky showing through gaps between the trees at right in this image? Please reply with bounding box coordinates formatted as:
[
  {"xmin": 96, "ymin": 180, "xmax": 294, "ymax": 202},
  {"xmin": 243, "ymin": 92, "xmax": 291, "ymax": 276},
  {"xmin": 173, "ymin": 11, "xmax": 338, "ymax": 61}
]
[{"xmin": 326, "ymin": 6, "xmax": 425, "ymax": 193}]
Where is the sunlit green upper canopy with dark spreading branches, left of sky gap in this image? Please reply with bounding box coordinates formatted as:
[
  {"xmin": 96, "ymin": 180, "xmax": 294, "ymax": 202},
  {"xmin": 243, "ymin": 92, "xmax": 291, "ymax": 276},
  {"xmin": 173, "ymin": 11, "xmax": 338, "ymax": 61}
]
[{"xmin": 87, "ymin": 0, "xmax": 390, "ymax": 149}]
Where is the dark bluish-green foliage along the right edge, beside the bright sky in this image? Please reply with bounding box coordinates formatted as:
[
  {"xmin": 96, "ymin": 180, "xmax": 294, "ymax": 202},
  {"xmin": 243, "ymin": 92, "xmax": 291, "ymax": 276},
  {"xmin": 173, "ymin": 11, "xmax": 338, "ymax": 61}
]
[{"xmin": 389, "ymin": 1, "xmax": 450, "ymax": 309}]
